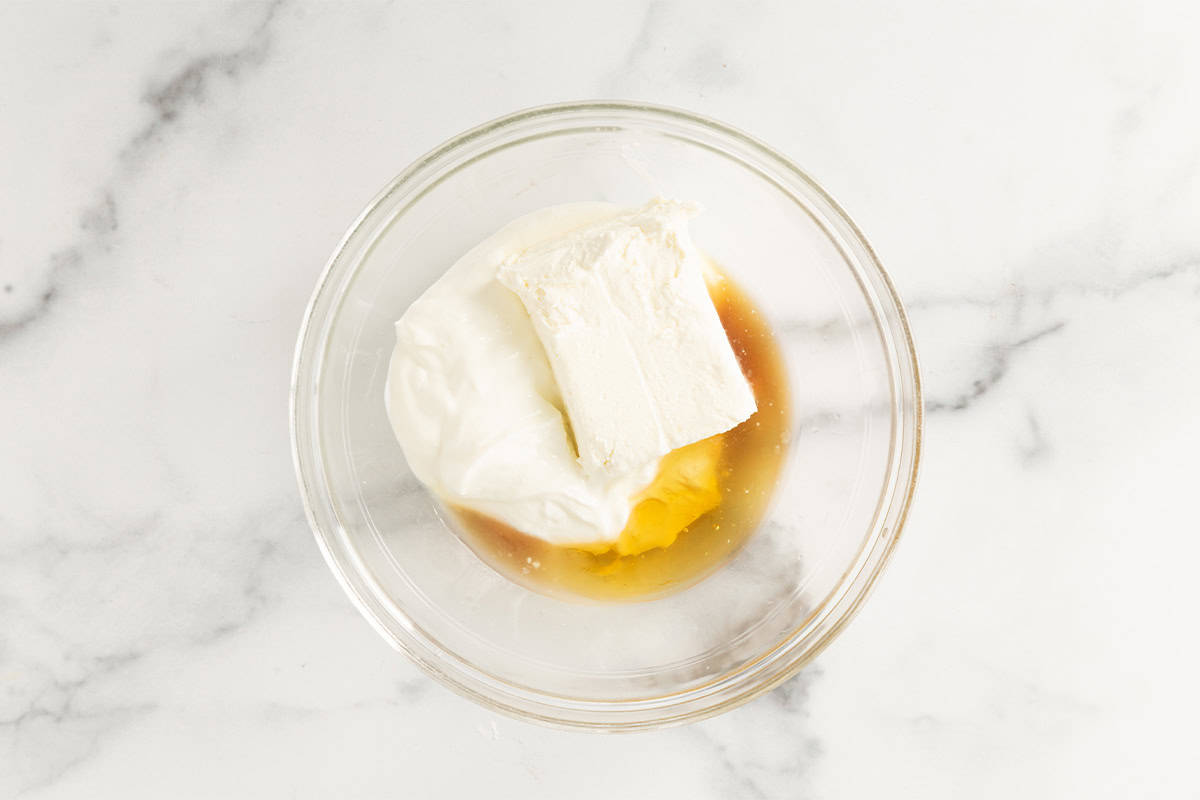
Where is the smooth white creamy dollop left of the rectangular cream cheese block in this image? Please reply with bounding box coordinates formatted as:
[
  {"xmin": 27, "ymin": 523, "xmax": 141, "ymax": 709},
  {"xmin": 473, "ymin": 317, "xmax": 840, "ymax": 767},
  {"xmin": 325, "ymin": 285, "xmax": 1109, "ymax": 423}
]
[{"xmin": 386, "ymin": 203, "xmax": 656, "ymax": 545}]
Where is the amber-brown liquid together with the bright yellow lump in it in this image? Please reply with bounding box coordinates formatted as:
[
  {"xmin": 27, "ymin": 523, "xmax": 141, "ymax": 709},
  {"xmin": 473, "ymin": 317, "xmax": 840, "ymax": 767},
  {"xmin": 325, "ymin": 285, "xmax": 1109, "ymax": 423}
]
[{"xmin": 451, "ymin": 279, "xmax": 790, "ymax": 600}]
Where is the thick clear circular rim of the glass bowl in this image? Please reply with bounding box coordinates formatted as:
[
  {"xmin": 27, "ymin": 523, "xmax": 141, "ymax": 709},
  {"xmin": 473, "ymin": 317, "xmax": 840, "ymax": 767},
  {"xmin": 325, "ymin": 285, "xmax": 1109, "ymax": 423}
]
[{"xmin": 288, "ymin": 101, "xmax": 924, "ymax": 730}]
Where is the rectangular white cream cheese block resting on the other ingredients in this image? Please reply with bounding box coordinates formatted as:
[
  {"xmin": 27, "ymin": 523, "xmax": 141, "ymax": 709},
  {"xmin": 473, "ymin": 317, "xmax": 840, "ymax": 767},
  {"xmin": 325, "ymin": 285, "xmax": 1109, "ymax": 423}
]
[{"xmin": 497, "ymin": 200, "xmax": 756, "ymax": 475}]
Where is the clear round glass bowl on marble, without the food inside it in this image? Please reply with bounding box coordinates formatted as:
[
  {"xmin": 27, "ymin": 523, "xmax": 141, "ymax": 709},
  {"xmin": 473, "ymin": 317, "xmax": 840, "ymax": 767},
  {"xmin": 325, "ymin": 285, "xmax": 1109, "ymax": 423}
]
[{"xmin": 292, "ymin": 102, "xmax": 922, "ymax": 730}]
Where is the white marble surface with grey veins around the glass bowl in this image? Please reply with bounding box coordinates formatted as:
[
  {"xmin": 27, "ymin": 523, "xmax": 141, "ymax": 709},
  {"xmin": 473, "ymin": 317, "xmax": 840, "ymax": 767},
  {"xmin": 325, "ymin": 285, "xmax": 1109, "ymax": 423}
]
[{"xmin": 0, "ymin": 0, "xmax": 1200, "ymax": 799}]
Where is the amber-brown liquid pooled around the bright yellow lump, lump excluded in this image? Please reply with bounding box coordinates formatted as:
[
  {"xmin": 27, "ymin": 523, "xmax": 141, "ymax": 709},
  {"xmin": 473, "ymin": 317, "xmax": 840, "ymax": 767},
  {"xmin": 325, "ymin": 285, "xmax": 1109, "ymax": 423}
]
[{"xmin": 452, "ymin": 279, "xmax": 790, "ymax": 600}]
